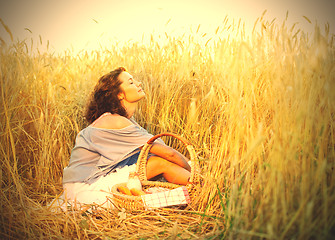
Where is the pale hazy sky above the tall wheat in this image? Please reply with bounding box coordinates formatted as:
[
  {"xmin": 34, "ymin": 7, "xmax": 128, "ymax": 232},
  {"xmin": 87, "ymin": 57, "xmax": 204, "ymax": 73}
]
[{"xmin": 0, "ymin": 0, "xmax": 335, "ymax": 52}]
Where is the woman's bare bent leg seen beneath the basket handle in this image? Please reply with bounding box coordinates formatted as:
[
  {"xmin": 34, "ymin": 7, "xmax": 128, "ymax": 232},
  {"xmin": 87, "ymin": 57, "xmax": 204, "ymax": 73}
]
[{"xmin": 147, "ymin": 156, "xmax": 191, "ymax": 185}]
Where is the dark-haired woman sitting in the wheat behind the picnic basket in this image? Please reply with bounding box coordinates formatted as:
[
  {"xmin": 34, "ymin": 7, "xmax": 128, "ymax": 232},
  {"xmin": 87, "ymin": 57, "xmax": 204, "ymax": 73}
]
[{"xmin": 63, "ymin": 67, "xmax": 191, "ymax": 207}]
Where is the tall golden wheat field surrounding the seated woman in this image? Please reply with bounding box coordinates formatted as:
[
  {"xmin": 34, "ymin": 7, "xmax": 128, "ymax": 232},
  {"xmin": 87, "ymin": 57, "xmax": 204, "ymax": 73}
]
[{"xmin": 0, "ymin": 14, "xmax": 335, "ymax": 239}]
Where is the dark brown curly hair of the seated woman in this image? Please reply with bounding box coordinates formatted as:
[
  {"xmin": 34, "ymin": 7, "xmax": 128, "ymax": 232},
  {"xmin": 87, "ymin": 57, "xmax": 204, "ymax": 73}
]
[{"xmin": 85, "ymin": 67, "xmax": 127, "ymax": 123}]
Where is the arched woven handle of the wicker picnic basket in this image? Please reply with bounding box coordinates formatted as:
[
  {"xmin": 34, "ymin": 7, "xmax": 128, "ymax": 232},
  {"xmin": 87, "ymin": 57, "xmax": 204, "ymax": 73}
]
[{"xmin": 136, "ymin": 132, "xmax": 200, "ymax": 184}]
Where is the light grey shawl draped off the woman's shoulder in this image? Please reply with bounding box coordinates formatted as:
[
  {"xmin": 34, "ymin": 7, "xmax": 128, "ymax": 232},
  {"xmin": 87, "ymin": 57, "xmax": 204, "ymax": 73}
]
[{"xmin": 63, "ymin": 119, "xmax": 164, "ymax": 184}]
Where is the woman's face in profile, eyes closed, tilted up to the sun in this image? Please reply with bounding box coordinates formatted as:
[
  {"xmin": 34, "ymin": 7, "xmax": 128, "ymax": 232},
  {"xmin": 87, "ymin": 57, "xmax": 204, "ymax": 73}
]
[{"xmin": 119, "ymin": 72, "xmax": 145, "ymax": 103}]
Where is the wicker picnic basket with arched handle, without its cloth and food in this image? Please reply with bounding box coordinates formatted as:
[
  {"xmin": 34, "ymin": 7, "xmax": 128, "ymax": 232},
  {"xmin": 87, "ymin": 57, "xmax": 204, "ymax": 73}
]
[{"xmin": 112, "ymin": 133, "xmax": 200, "ymax": 210}]
